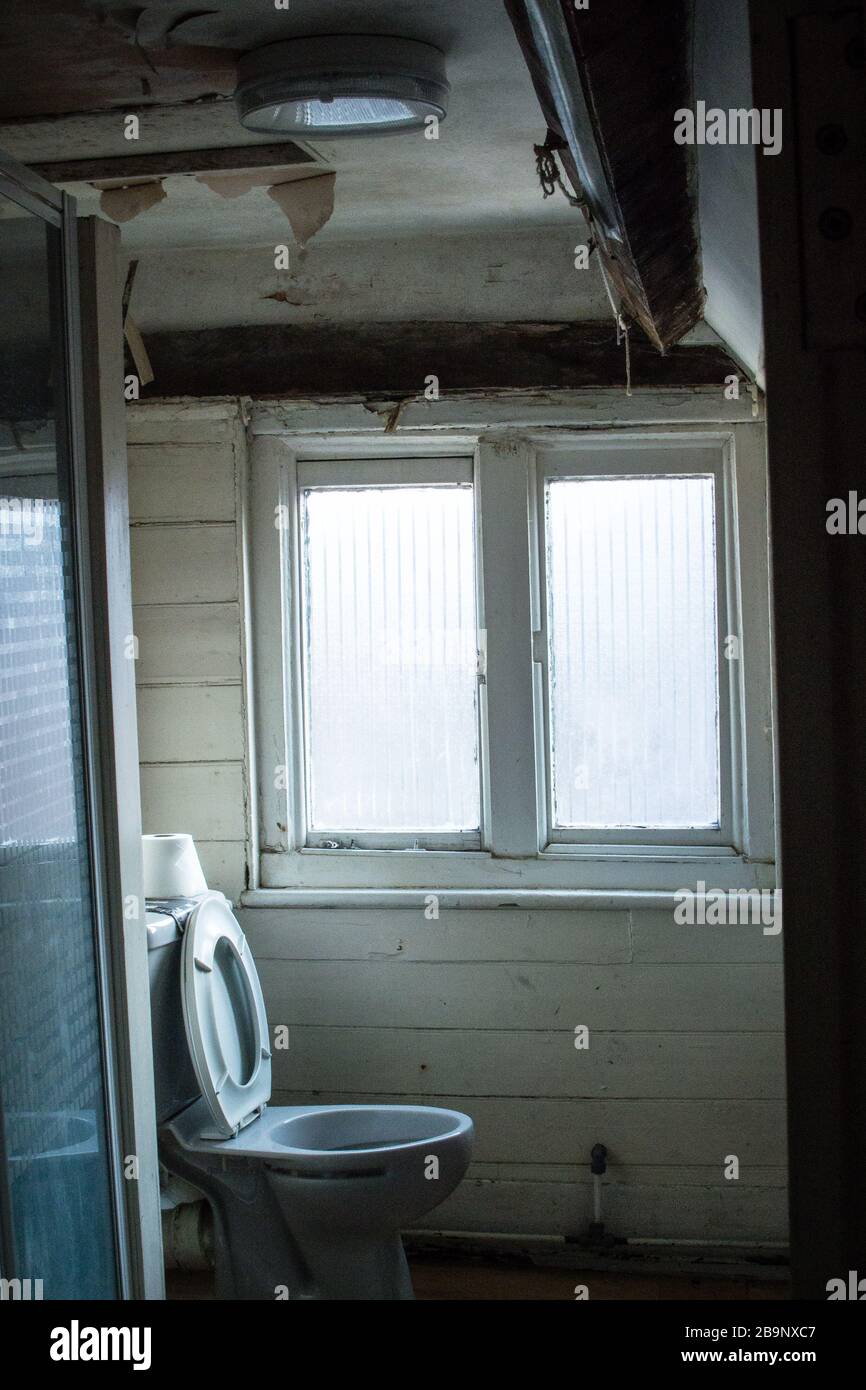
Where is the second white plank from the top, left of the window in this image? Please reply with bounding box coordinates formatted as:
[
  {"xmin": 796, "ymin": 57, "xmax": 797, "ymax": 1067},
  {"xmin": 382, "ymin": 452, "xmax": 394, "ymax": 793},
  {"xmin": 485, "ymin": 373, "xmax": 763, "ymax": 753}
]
[{"xmin": 129, "ymin": 445, "xmax": 235, "ymax": 521}]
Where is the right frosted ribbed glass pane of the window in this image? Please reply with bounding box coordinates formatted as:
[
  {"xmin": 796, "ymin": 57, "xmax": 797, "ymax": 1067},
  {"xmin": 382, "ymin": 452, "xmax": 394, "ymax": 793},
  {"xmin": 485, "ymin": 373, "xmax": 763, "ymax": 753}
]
[{"xmin": 546, "ymin": 477, "xmax": 720, "ymax": 828}]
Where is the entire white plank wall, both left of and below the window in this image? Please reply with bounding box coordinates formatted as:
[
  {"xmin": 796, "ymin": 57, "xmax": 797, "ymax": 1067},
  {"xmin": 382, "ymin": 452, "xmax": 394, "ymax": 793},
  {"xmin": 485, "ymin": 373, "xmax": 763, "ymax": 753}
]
[{"xmin": 129, "ymin": 406, "xmax": 785, "ymax": 1241}]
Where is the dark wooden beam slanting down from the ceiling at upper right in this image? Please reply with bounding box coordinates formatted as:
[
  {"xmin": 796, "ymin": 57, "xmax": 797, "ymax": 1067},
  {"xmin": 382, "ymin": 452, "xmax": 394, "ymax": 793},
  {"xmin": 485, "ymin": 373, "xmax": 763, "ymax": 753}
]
[{"xmin": 505, "ymin": 0, "xmax": 703, "ymax": 352}]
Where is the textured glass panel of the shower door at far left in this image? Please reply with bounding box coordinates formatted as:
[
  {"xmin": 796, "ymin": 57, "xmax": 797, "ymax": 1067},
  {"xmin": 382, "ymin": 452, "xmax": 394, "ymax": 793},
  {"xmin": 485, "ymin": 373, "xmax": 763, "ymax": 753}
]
[{"xmin": 0, "ymin": 168, "xmax": 124, "ymax": 1300}]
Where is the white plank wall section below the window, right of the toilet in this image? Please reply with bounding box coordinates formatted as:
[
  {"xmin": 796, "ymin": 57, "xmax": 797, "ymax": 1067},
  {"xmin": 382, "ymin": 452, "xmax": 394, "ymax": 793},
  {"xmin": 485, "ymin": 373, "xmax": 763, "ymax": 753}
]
[{"xmin": 240, "ymin": 901, "xmax": 785, "ymax": 1241}]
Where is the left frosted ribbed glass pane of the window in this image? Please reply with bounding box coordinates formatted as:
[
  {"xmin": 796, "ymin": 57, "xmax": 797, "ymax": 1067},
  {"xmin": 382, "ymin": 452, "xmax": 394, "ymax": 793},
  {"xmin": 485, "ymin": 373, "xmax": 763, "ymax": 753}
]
[{"xmin": 302, "ymin": 487, "xmax": 480, "ymax": 833}]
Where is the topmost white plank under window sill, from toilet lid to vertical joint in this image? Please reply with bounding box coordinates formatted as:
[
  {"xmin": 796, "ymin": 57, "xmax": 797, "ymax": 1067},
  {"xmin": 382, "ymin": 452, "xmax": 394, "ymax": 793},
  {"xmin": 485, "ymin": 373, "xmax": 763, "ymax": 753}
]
[{"xmin": 239, "ymin": 899, "xmax": 630, "ymax": 965}]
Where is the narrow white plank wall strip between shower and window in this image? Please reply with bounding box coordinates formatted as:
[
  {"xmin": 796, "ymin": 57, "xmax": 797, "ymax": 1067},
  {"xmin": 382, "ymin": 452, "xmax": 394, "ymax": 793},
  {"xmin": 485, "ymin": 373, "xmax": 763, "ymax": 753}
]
[{"xmin": 128, "ymin": 409, "xmax": 250, "ymax": 899}]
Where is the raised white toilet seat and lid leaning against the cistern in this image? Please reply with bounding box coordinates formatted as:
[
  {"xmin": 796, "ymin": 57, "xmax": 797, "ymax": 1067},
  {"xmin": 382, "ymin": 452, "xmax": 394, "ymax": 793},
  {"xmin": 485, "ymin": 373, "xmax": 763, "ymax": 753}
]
[{"xmin": 181, "ymin": 897, "xmax": 271, "ymax": 1138}]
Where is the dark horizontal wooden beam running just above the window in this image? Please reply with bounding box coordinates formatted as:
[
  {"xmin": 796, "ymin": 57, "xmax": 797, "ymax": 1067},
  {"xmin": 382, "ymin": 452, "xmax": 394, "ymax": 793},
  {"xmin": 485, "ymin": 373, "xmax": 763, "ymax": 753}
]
[{"xmin": 132, "ymin": 321, "xmax": 737, "ymax": 398}]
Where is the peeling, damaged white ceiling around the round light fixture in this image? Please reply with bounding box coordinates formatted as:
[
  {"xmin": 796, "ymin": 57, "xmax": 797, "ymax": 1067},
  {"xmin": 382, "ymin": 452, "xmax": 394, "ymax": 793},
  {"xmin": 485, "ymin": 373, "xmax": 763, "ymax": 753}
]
[{"xmin": 0, "ymin": 0, "xmax": 739, "ymax": 380}]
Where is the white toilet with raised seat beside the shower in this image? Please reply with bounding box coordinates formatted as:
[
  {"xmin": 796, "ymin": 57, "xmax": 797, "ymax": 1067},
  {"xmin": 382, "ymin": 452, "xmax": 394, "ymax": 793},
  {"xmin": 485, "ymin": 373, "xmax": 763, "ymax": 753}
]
[{"xmin": 147, "ymin": 892, "xmax": 473, "ymax": 1300}]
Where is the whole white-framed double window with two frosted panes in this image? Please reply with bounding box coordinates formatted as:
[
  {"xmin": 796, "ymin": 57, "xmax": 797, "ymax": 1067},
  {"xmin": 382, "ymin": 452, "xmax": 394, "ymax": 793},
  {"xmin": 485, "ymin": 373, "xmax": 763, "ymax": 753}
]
[{"xmin": 250, "ymin": 424, "xmax": 773, "ymax": 901}]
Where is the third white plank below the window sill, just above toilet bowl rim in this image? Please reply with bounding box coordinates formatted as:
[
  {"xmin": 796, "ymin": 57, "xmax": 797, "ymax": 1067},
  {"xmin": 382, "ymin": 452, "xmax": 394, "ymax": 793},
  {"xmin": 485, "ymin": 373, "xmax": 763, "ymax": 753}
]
[{"xmin": 272, "ymin": 1026, "xmax": 784, "ymax": 1099}]
